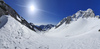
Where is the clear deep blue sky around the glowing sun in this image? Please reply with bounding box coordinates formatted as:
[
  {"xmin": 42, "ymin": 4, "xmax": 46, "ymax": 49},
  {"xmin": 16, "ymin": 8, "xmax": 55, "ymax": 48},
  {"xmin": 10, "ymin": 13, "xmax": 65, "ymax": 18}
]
[{"xmin": 4, "ymin": 0, "xmax": 100, "ymax": 25}]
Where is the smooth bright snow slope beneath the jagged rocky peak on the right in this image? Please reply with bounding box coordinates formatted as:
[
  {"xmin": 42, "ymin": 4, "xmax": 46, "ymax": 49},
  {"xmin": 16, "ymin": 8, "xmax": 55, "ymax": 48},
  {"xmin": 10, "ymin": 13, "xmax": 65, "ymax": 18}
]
[{"xmin": 46, "ymin": 18, "xmax": 100, "ymax": 37}]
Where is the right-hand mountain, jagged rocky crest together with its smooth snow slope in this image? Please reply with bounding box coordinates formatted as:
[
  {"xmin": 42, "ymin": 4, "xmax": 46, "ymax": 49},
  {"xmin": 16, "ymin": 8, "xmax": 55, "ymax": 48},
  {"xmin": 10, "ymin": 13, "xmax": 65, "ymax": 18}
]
[{"xmin": 46, "ymin": 8, "xmax": 100, "ymax": 37}]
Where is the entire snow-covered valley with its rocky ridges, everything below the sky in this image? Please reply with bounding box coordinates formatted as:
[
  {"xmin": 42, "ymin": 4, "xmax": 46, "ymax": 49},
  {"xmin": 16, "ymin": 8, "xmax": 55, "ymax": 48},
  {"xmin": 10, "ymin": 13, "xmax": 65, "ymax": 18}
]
[{"xmin": 0, "ymin": 0, "xmax": 100, "ymax": 49}]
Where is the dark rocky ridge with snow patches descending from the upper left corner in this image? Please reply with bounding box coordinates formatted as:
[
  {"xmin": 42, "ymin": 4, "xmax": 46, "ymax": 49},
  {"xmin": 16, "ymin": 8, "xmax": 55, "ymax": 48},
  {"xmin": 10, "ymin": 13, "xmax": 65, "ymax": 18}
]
[{"xmin": 0, "ymin": 0, "xmax": 41, "ymax": 31}]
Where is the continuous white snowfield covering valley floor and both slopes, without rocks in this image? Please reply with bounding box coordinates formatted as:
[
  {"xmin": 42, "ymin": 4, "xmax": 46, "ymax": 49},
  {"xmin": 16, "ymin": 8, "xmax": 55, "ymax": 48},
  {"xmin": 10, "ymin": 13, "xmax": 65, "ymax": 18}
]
[{"xmin": 0, "ymin": 15, "xmax": 100, "ymax": 49}]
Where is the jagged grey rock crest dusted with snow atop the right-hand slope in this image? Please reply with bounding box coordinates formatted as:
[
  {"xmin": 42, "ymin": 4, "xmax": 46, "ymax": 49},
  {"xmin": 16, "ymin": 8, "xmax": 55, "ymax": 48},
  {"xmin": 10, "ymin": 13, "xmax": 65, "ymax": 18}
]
[{"xmin": 55, "ymin": 8, "xmax": 100, "ymax": 28}]
